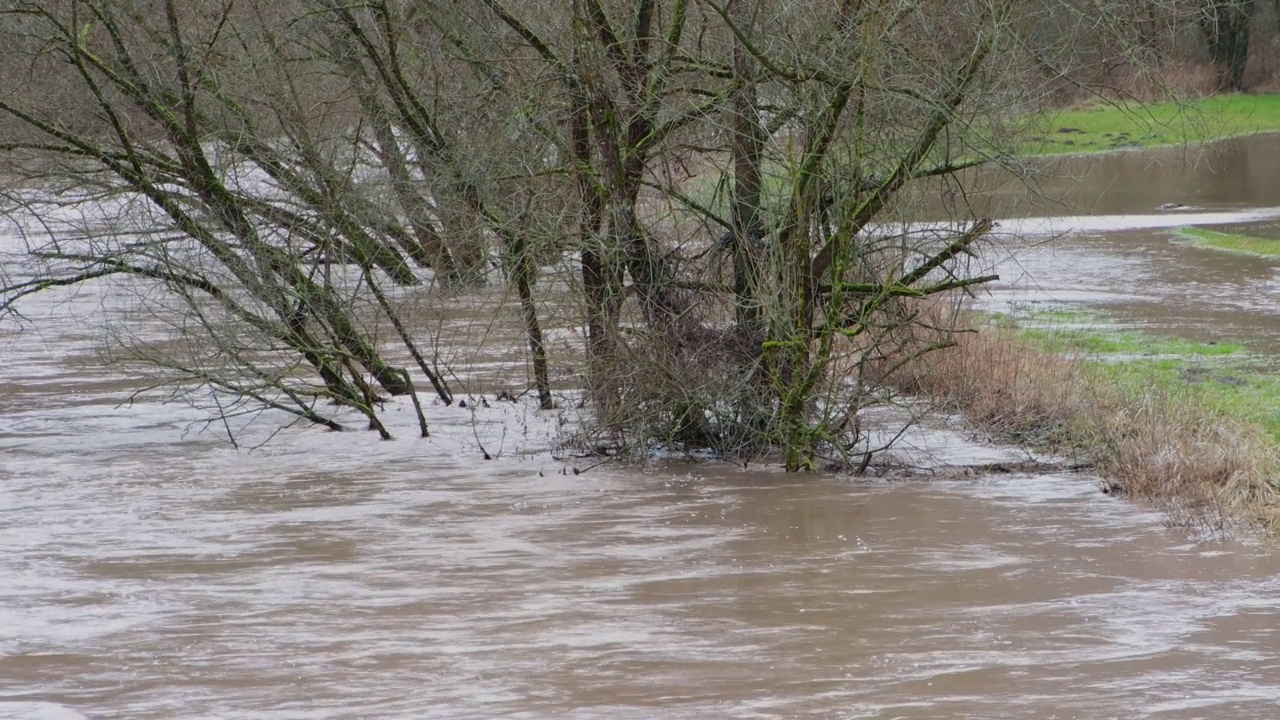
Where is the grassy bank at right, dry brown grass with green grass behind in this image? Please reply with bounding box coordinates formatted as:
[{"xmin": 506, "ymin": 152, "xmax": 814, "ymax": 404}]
[{"xmin": 909, "ymin": 304, "xmax": 1280, "ymax": 529}]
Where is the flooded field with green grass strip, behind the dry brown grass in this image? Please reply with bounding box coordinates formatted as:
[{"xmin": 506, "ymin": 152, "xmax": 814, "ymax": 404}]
[{"xmin": 979, "ymin": 135, "xmax": 1280, "ymax": 438}]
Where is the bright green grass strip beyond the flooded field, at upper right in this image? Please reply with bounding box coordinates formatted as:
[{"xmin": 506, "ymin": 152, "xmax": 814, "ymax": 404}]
[{"xmin": 1021, "ymin": 95, "xmax": 1280, "ymax": 155}]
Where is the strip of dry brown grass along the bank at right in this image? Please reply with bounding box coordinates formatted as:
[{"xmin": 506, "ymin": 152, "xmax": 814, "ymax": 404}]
[{"xmin": 896, "ymin": 322, "xmax": 1280, "ymax": 530}]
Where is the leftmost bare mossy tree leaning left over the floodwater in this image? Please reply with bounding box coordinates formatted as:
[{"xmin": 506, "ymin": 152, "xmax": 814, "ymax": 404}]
[{"xmin": 0, "ymin": 0, "xmax": 447, "ymax": 434}]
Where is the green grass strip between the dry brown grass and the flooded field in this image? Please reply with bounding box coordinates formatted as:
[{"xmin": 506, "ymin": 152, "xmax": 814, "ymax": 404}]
[{"xmin": 988, "ymin": 310, "xmax": 1280, "ymax": 442}]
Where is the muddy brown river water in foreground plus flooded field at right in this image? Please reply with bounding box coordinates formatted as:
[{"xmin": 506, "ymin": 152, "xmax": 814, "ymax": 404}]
[{"xmin": 0, "ymin": 138, "xmax": 1280, "ymax": 720}]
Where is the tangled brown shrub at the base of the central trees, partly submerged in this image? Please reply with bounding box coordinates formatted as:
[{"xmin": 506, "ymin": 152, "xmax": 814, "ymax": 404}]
[{"xmin": 579, "ymin": 283, "xmax": 955, "ymax": 461}]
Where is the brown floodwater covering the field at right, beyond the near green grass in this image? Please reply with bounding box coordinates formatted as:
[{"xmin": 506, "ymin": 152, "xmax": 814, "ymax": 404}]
[{"xmin": 980, "ymin": 136, "xmax": 1280, "ymax": 359}]
